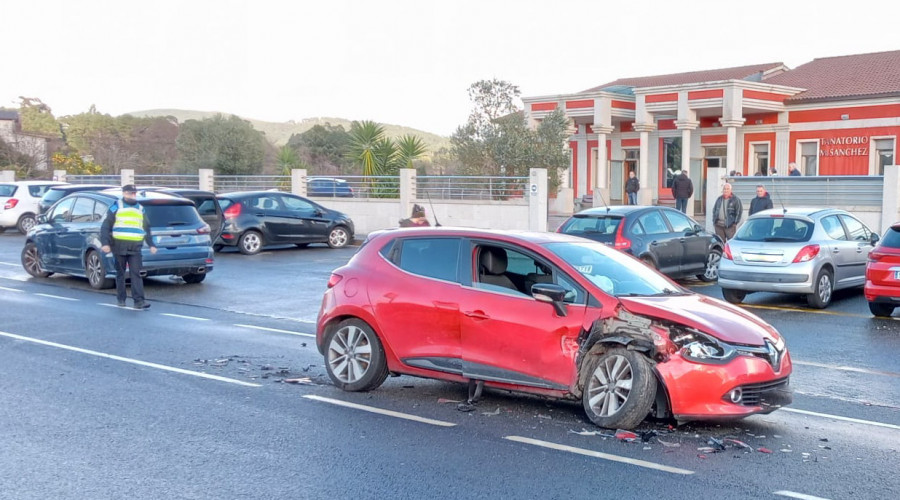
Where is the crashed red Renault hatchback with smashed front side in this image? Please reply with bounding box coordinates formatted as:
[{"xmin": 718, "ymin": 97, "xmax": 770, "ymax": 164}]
[{"xmin": 316, "ymin": 228, "xmax": 792, "ymax": 428}]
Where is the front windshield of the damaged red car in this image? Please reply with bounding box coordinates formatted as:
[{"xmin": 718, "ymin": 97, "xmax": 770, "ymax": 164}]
[{"xmin": 547, "ymin": 242, "xmax": 688, "ymax": 297}]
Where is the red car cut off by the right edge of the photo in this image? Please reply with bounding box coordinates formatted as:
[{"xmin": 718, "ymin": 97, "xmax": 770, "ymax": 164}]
[{"xmin": 864, "ymin": 222, "xmax": 900, "ymax": 317}]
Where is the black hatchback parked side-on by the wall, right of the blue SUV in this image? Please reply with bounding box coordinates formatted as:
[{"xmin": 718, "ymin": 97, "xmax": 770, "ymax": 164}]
[{"xmin": 215, "ymin": 191, "xmax": 353, "ymax": 255}]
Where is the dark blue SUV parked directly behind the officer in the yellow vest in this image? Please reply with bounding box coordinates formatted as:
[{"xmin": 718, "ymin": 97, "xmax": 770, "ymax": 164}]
[{"xmin": 22, "ymin": 189, "xmax": 213, "ymax": 289}]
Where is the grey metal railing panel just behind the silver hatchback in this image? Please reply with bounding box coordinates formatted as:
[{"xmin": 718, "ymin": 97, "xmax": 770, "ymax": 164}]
[{"xmin": 727, "ymin": 175, "xmax": 884, "ymax": 207}]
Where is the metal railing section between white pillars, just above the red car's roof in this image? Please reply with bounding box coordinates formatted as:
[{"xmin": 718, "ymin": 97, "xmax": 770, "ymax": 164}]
[{"xmin": 416, "ymin": 175, "xmax": 528, "ymax": 203}]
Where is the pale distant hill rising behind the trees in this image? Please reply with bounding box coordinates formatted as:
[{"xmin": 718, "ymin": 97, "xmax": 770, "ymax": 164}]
[{"xmin": 126, "ymin": 109, "xmax": 450, "ymax": 153}]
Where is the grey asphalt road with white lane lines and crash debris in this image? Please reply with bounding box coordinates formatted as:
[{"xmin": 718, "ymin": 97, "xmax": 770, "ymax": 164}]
[{"xmin": 0, "ymin": 232, "xmax": 900, "ymax": 499}]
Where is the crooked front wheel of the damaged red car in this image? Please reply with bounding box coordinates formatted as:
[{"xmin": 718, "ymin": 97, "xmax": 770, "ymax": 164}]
[{"xmin": 581, "ymin": 347, "xmax": 657, "ymax": 429}]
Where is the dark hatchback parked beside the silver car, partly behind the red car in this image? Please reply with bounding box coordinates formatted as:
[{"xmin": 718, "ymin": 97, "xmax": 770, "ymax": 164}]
[{"xmin": 557, "ymin": 205, "xmax": 724, "ymax": 281}]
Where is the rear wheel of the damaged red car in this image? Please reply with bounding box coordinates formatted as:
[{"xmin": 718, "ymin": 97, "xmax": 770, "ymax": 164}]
[{"xmin": 324, "ymin": 318, "xmax": 388, "ymax": 392}]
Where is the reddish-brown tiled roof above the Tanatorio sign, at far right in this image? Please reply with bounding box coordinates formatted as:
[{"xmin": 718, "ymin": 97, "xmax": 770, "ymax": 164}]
[{"xmin": 766, "ymin": 50, "xmax": 900, "ymax": 103}]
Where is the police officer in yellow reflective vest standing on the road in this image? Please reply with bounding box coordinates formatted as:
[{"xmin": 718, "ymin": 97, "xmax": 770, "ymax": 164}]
[{"xmin": 100, "ymin": 184, "xmax": 156, "ymax": 309}]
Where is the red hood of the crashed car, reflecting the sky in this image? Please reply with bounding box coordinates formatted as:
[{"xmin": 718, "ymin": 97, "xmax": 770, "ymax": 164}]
[{"xmin": 619, "ymin": 293, "xmax": 781, "ymax": 346}]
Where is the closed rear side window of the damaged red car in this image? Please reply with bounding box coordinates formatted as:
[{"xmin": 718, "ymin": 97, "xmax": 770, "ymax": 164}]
[{"xmin": 395, "ymin": 238, "xmax": 460, "ymax": 282}]
